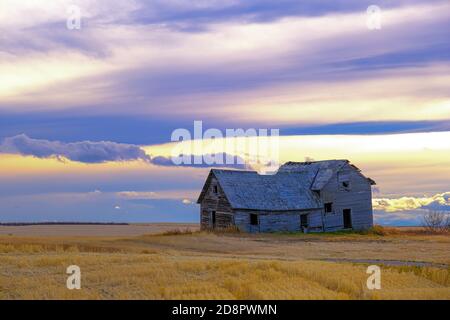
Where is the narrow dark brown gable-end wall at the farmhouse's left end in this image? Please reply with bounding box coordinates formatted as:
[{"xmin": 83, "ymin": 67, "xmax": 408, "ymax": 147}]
[{"xmin": 200, "ymin": 176, "xmax": 234, "ymax": 230}]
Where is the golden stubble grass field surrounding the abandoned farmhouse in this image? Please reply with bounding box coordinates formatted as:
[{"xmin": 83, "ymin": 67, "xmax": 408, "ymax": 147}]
[{"xmin": 0, "ymin": 225, "xmax": 450, "ymax": 300}]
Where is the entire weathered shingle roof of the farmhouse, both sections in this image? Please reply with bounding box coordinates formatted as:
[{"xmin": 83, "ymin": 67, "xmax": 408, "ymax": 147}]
[{"xmin": 197, "ymin": 160, "xmax": 375, "ymax": 211}]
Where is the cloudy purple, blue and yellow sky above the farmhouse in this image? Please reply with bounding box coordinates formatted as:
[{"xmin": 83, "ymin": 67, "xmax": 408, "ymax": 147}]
[{"xmin": 0, "ymin": 0, "xmax": 450, "ymax": 225}]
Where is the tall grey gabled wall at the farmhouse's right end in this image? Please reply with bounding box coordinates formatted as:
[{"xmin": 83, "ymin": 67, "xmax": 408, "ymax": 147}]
[{"xmin": 321, "ymin": 165, "xmax": 373, "ymax": 231}]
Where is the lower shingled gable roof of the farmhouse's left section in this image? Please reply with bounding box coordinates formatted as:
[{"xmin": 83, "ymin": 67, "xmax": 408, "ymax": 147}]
[{"xmin": 197, "ymin": 169, "xmax": 321, "ymax": 211}]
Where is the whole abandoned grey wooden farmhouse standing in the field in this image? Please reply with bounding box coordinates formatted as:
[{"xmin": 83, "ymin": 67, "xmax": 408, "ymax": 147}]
[{"xmin": 197, "ymin": 160, "xmax": 375, "ymax": 232}]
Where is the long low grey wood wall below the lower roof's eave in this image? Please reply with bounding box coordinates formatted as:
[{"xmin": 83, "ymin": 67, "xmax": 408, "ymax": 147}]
[{"xmin": 234, "ymin": 210, "xmax": 322, "ymax": 233}]
